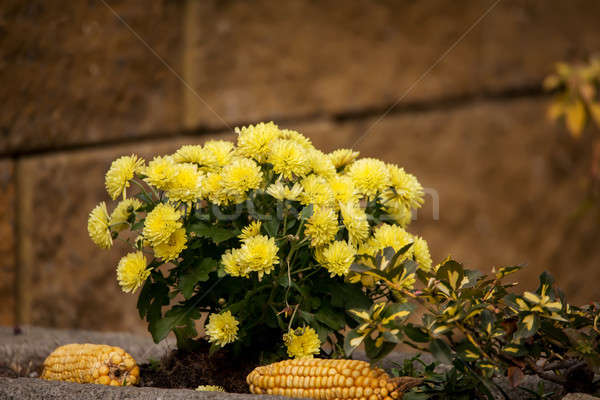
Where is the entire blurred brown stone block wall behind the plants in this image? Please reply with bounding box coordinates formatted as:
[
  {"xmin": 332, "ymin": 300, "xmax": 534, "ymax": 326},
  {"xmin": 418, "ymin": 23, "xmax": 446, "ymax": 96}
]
[{"xmin": 0, "ymin": 0, "xmax": 600, "ymax": 333}]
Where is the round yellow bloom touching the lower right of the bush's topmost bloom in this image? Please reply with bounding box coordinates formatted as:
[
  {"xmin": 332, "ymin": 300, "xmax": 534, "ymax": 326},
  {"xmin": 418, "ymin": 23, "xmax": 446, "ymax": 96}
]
[{"xmin": 268, "ymin": 140, "xmax": 311, "ymax": 180}]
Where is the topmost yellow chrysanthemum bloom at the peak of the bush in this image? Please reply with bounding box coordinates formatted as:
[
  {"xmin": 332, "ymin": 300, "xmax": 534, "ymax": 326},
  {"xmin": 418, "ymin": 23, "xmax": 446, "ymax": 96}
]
[{"xmin": 235, "ymin": 122, "xmax": 281, "ymax": 162}]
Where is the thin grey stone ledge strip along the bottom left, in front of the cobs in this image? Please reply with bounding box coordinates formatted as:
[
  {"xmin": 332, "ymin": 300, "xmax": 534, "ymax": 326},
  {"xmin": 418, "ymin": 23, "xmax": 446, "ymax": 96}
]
[{"xmin": 0, "ymin": 378, "xmax": 274, "ymax": 400}]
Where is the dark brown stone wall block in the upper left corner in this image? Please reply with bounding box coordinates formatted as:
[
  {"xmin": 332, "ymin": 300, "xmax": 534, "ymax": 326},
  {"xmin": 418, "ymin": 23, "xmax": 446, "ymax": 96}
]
[{"xmin": 0, "ymin": 1, "xmax": 183, "ymax": 154}]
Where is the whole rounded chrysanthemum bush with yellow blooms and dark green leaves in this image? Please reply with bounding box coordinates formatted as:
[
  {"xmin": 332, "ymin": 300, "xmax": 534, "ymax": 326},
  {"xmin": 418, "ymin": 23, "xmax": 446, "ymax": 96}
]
[{"xmin": 88, "ymin": 123, "xmax": 432, "ymax": 360}]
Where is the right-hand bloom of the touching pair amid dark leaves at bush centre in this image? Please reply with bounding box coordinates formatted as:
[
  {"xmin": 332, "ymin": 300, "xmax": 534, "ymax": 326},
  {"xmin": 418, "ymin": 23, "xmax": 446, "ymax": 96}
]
[{"xmin": 238, "ymin": 235, "xmax": 279, "ymax": 280}]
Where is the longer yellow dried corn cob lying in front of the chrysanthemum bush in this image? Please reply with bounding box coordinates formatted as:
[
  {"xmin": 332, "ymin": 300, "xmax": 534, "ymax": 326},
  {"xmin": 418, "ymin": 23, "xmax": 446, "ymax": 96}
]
[{"xmin": 246, "ymin": 359, "xmax": 421, "ymax": 400}]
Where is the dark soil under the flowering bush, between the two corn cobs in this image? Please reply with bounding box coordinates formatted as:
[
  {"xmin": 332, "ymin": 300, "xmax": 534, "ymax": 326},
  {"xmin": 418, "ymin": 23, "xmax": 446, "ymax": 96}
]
[{"xmin": 140, "ymin": 345, "xmax": 258, "ymax": 393}]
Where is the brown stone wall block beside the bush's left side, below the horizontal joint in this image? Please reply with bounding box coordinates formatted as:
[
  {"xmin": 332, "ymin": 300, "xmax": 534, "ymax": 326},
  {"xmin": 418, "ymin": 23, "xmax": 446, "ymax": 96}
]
[{"xmin": 31, "ymin": 136, "xmax": 230, "ymax": 333}]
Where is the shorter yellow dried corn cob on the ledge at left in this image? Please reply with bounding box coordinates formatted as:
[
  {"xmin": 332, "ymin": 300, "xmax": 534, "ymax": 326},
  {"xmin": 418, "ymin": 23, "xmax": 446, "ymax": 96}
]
[{"xmin": 42, "ymin": 344, "xmax": 140, "ymax": 386}]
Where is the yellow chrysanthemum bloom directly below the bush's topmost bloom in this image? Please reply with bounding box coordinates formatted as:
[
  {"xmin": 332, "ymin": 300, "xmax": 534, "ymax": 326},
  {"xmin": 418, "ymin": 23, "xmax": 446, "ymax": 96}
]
[{"xmin": 221, "ymin": 158, "xmax": 263, "ymax": 203}]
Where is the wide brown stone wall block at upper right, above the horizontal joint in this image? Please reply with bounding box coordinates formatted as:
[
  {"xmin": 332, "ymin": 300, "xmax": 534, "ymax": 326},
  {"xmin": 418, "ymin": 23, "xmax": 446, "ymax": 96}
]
[{"xmin": 186, "ymin": 0, "xmax": 600, "ymax": 126}]
